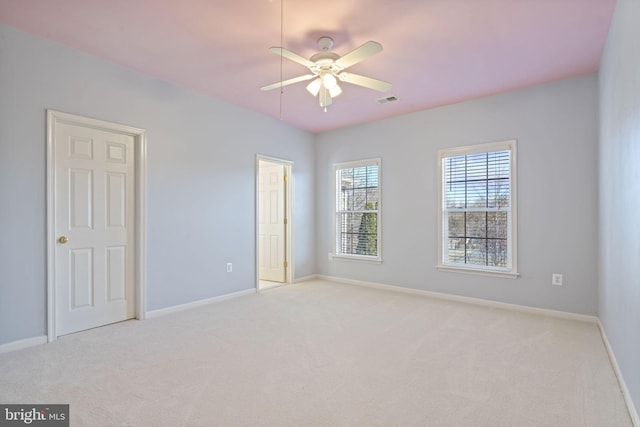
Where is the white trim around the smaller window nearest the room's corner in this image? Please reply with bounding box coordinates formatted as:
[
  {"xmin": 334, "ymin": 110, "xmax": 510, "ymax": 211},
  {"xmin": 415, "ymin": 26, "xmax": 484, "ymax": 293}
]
[{"xmin": 330, "ymin": 157, "xmax": 382, "ymax": 264}]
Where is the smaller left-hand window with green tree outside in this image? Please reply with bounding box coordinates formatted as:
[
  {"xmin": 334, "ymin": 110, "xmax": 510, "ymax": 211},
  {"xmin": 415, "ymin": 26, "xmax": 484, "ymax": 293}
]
[{"xmin": 334, "ymin": 159, "xmax": 382, "ymax": 262}]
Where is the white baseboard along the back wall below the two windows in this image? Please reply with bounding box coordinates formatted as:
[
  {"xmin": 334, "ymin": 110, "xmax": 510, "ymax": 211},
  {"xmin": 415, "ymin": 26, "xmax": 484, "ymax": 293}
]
[{"xmin": 317, "ymin": 275, "xmax": 598, "ymax": 323}]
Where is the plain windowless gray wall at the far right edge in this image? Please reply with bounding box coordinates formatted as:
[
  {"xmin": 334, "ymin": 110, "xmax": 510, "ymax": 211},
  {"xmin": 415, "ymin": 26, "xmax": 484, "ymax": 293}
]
[{"xmin": 599, "ymin": 0, "xmax": 640, "ymax": 416}]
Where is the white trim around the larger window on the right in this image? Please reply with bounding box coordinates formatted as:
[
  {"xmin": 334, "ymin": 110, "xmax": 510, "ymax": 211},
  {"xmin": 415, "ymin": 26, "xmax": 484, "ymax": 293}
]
[{"xmin": 436, "ymin": 139, "xmax": 520, "ymax": 279}]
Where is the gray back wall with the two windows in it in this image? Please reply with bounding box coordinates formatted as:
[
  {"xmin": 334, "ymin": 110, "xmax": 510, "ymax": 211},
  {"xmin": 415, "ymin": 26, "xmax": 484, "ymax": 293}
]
[{"xmin": 316, "ymin": 75, "xmax": 598, "ymax": 315}]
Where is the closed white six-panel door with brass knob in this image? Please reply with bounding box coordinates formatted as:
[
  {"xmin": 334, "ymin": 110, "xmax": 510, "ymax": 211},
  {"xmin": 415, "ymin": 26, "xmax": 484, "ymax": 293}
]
[{"xmin": 55, "ymin": 123, "xmax": 135, "ymax": 335}]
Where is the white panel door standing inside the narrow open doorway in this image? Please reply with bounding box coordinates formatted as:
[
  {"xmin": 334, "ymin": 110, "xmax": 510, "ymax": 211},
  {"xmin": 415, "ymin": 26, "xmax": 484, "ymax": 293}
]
[{"xmin": 258, "ymin": 160, "xmax": 286, "ymax": 282}]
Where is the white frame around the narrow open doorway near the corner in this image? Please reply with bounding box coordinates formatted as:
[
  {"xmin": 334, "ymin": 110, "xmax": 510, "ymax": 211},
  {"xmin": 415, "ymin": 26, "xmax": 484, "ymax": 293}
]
[{"xmin": 254, "ymin": 154, "xmax": 295, "ymax": 291}]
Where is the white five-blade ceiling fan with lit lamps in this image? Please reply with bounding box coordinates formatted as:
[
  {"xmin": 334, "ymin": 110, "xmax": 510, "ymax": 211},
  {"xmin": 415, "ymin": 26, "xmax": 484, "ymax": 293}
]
[{"xmin": 260, "ymin": 37, "xmax": 391, "ymax": 111}]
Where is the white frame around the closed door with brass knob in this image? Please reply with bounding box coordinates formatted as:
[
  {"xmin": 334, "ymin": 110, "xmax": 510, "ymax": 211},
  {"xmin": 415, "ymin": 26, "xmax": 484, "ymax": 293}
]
[{"xmin": 47, "ymin": 110, "xmax": 147, "ymax": 342}]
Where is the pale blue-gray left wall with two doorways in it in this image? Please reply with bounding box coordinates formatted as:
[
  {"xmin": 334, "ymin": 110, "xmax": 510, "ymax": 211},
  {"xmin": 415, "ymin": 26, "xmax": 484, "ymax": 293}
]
[{"xmin": 0, "ymin": 26, "xmax": 316, "ymax": 344}]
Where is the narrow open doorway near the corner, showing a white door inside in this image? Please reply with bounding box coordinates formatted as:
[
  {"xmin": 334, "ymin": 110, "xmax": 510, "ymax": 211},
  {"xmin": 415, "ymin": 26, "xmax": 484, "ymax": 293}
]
[{"xmin": 256, "ymin": 156, "xmax": 293, "ymax": 290}]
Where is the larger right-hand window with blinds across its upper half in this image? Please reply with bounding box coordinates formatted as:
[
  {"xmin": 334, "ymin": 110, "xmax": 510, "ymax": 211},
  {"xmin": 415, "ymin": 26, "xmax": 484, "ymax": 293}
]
[{"xmin": 438, "ymin": 141, "xmax": 518, "ymax": 277}]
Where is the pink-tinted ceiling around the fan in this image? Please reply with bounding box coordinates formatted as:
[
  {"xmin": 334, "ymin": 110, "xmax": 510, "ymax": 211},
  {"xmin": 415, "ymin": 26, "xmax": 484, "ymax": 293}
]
[{"xmin": 0, "ymin": 0, "xmax": 615, "ymax": 132}]
